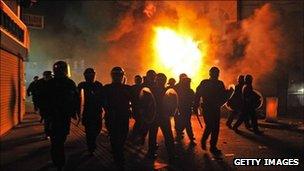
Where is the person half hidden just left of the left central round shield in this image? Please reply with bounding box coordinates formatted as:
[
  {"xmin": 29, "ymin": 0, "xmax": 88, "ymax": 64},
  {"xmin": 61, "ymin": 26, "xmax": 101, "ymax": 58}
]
[{"xmin": 132, "ymin": 75, "xmax": 142, "ymax": 140}]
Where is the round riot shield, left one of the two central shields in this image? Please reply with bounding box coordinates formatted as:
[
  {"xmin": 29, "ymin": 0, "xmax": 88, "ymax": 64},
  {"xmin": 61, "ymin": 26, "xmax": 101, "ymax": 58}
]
[{"xmin": 139, "ymin": 87, "xmax": 156, "ymax": 124}]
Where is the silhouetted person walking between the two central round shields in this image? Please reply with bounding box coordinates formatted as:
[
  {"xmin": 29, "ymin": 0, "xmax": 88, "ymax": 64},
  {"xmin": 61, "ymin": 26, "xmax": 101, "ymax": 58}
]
[{"xmin": 147, "ymin": 73, "xmax": 175, "ymax": 160}]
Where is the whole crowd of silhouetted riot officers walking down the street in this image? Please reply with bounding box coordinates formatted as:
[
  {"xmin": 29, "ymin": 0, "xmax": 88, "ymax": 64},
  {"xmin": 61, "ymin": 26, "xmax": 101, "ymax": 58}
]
[{"xmin": 27, "ymin": 61, "xmax": 262, "ymax": 170}]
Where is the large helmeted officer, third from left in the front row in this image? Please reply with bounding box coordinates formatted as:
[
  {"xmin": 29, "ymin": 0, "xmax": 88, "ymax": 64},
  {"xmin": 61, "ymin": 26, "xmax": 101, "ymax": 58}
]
[{"xmin": 104, "ymin": 67, "xmax": 132, "ymax": 169}]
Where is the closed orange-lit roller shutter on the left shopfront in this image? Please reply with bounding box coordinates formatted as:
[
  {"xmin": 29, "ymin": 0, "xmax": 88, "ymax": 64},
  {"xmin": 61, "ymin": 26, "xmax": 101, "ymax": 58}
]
[{"xmin": 0, "ymin": 49, "xmax": 23, "ymax": 135}]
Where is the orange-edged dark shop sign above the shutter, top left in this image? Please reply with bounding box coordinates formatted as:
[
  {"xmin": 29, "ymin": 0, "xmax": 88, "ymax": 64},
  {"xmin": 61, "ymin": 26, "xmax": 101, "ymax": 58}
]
[{"xmin": 0, "ymin": 0, "xmax": 29, "ymax": 49}]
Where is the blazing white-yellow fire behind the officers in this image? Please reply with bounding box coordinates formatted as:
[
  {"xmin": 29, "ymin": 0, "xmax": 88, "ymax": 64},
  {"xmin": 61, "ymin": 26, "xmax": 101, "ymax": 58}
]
[{"xmin": 153, "ymin": 27, "xmax": 205, "ymax": 88}]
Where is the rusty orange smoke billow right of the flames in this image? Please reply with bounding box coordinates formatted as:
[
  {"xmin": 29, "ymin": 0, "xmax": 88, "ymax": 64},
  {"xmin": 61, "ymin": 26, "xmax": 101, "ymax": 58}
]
[{"xmin": 220, "ymin": 4, "xmax": 286, "ymax": 91}]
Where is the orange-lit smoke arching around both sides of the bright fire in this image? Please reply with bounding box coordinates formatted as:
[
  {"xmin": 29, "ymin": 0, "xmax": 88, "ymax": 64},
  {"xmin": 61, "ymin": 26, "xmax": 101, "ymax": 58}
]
[{"xmin": 107, "ymin": 1, "xmax": 287, "ymax": 91}]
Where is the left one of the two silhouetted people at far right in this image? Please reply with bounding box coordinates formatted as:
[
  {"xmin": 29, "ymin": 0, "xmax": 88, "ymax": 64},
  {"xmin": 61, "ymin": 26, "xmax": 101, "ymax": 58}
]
[{"xmin": 226, "ymin": 75, "xmax": 250, "ymax": 129}]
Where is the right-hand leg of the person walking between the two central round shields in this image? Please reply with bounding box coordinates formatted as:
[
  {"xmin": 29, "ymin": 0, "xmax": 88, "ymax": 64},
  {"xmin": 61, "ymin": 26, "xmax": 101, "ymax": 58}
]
[{"xmin": 160, "ymin": 118, "xmax": 175, "ymax": 158}]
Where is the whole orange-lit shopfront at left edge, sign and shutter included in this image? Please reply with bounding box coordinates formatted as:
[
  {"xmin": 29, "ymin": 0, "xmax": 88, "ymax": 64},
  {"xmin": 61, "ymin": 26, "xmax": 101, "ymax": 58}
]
[{"xmin": 0, "ymin": 0, "xmax": 29, "ymax": 136}]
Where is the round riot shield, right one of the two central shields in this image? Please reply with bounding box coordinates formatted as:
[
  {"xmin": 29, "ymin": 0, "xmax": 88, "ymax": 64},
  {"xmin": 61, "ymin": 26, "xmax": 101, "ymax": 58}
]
[{"xmin": 162, "ymin": 88, "xmax": 178, "ymax": 116}]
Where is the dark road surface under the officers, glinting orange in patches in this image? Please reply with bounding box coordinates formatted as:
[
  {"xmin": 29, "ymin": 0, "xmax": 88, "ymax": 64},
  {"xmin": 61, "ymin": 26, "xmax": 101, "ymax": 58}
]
[{"xmin": 0, "ymin": 114, "xmax": 304, "ymax": 171}]
